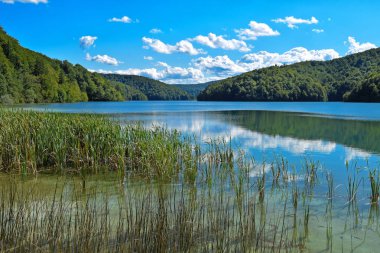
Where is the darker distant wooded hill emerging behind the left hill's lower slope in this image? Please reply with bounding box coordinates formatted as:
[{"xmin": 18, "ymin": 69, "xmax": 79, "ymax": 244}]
[{"xmin": 103, "ymin": 74, "xmax": 192, "ymax": 100}]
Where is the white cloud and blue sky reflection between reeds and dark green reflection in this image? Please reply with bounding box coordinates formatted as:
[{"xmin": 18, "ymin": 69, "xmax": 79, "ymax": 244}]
[{"xmin": 119, "ymin": 110, "xmax": 379, "ymax": 182}]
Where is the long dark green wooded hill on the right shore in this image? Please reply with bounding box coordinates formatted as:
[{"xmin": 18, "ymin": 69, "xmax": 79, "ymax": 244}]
[{"xmin": 198, "ymin": 49, "xmax": 380, "ymax": 102}]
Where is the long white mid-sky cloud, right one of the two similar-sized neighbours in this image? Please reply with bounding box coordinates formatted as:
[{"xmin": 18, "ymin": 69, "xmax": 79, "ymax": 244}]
[{"xmin": 192, "ymin": 33, "xmax": 251, "ymax": 52}]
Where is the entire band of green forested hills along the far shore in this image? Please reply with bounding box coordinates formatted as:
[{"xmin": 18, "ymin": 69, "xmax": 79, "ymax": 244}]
[{"xmin": 0, "ymin": 23, "xmax": 380, "ymax": 104}]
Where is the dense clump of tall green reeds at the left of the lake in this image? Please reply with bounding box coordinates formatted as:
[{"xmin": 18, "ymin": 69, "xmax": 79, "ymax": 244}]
[{"xmin": 0, "ymin": 109, "xmax": 196, "ymax": 178}]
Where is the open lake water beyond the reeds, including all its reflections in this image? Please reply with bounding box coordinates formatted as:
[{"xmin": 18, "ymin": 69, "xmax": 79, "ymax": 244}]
[{"xmin": 20, "ymin": 101, "xmax": 380, "ymax": 170}]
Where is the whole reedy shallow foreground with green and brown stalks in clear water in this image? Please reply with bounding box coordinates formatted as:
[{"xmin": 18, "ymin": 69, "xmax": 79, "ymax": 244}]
[{"xmin": 0, "ymin": 110, "xmax": 380, "ymax": 252}]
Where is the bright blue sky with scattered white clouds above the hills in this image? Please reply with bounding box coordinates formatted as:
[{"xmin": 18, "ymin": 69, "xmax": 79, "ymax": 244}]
[{"xmin": 0, "ymin": 0, "xmax": 380, "ymax": 84}]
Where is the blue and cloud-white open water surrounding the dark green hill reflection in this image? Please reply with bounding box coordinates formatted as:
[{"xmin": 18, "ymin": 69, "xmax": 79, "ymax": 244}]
[{"xmin": 23, "ymin": 101, "xmax": 380, "ymax": 182}]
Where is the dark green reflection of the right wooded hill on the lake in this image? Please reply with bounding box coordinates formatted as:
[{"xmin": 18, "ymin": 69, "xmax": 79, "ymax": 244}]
[{"xmin": 212, "ymin": 111, "xmax": 380, "ymax": 153}]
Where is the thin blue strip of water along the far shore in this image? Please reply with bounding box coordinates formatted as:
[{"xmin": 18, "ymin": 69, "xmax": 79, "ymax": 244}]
[{"xmin": 23, "ymin": 101, "xmax": 380, "ymax": 120}]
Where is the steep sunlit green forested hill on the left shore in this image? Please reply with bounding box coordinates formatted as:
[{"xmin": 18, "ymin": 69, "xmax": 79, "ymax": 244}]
[{"xmin": 0, "ymin": 27, "xmax": 147, "ymax": 103}]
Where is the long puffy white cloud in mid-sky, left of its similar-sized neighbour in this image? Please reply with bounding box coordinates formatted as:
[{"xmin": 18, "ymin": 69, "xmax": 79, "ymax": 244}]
[{"xmin": 142, "ymin": 37, "xmax": 204, "ymax": 55}]
